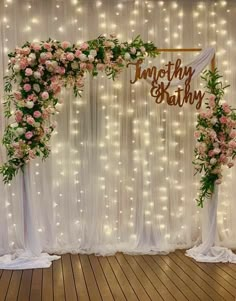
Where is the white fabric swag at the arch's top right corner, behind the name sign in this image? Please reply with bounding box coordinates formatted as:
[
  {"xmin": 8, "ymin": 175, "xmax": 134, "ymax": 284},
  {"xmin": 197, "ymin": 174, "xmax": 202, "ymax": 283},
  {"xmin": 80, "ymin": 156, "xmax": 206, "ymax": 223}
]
[{"xmin": 146, "ymin": 47, "xmax": 215, "ymax": 87}]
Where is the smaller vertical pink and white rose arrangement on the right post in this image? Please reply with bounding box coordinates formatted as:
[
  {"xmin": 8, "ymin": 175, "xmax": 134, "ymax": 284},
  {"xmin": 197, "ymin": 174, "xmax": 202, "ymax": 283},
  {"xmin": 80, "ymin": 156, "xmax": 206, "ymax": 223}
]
[{"xmin": 193, "ymin": 69, "xmax": 236, "ymax": 207}]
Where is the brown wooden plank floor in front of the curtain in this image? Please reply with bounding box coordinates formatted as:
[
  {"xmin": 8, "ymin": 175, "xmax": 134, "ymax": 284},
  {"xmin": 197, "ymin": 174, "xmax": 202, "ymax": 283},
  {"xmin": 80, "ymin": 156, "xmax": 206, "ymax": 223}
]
[{"xmin": 0, "ymin": 251, "xmax": 236, "ymax": 301}]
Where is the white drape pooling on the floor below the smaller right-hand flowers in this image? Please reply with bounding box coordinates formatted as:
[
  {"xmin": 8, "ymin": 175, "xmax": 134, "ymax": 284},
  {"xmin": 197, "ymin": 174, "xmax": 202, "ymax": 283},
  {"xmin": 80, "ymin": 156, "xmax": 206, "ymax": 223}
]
[{"xmin": 186, "ymin": 185, "xmax": 236, "ymax": 263}]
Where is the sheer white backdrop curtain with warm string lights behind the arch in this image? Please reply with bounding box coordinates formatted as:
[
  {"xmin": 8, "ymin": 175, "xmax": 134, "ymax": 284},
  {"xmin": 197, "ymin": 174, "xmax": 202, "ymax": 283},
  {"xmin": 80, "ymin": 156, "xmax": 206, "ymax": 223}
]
[{"xmin": 0, "ymin": 0, "xmax": 236, "ymax": 254}]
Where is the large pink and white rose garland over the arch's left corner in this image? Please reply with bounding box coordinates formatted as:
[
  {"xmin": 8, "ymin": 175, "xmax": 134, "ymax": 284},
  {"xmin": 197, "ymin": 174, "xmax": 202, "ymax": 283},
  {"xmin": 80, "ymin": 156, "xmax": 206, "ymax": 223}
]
[{"xmin": 0, "ymin": 36, "xmax": 158, "ymax": 183}]
